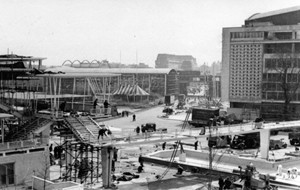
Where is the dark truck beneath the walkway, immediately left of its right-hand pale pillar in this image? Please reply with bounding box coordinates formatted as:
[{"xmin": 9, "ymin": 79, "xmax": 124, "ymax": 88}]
[{"xmin": 230, "ymin": 132, "xmax": 260, "ymax": 150}]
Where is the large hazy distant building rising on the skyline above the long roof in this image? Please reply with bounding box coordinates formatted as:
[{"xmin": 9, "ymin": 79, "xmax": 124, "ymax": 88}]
[{"xmin": 155, "ymin": 54, "xmax": 197, "ymax": 70}]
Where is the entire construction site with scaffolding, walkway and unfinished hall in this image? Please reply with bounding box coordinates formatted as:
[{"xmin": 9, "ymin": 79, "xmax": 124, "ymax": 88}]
[{"xmin": 0, "ymin": 55, "xmax": 300, "ymax": 190}]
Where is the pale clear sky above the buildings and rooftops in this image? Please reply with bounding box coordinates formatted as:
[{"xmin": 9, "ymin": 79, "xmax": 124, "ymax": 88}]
[{"xmin": 0, "ymin": 0, "xmax": 300, "ymax": 67}]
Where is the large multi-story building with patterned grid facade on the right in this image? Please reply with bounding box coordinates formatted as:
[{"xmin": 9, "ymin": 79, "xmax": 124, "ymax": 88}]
[{"xmin": 221, "ymin": 6, "xmax": 300, "ymax": 119}]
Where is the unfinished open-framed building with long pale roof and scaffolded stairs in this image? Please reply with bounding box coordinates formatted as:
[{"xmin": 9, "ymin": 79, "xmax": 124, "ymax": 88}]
[{"xmin": 0, "ymin": 55, "xmax": 223, "ymax": 189}]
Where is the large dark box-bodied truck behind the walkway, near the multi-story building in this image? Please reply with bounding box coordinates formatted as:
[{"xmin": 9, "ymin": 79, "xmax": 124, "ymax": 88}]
[{"xmin": 189, "ymin": 107, "xmax": 220, "ymax": 127}]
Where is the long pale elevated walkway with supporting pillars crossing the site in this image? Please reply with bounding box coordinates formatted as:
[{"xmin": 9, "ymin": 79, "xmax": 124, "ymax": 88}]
[{"xmin": 63, "ymin": 117, "xmax": 300, "ymax": 189}]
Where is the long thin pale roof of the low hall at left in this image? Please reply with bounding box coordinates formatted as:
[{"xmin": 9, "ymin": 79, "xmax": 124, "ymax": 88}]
[{"xmin": 46, "ymin": 66, "xmax": 175, "ymax": 74}]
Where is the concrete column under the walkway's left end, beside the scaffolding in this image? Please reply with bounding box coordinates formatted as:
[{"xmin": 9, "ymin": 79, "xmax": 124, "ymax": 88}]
[{"xmin": 101, "ymin": 146, "xmax": 113, "ymax": 188}]
